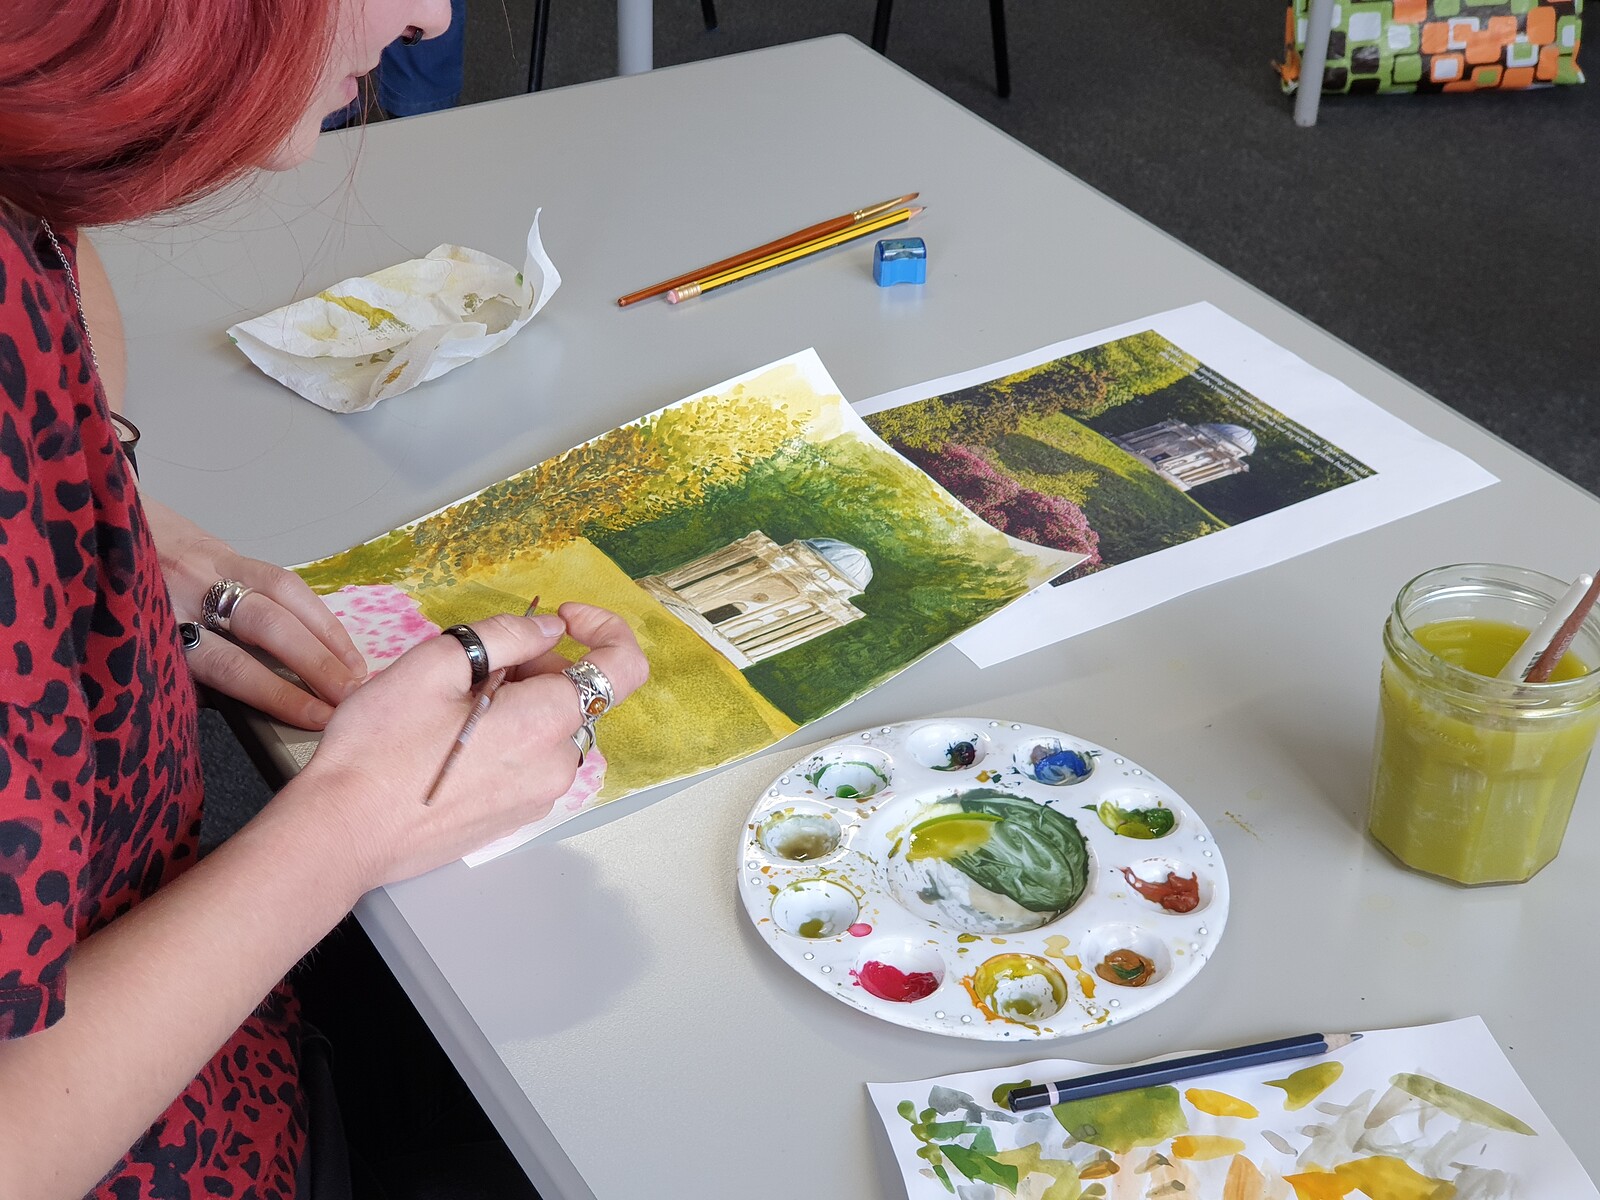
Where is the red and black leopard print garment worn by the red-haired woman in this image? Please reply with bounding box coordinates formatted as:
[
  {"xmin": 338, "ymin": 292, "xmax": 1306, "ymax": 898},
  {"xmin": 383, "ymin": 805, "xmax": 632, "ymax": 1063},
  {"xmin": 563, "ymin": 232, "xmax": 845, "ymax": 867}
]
[{"xmin": 0, "ymin": 216, "xmax": 306, "ymax": 1200}]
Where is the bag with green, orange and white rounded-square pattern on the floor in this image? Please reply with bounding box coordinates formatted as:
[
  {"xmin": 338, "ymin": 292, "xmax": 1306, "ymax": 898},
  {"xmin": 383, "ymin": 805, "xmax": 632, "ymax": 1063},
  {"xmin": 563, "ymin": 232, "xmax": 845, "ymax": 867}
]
[{"xmin": 1278, "ymin": 0, "xmax": 1584, "ymax": 93}]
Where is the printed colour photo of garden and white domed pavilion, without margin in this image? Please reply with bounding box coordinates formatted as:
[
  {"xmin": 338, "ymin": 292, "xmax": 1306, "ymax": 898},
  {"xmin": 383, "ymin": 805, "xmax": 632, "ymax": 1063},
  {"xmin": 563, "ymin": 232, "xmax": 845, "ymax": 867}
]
[{"xmin": 867, "ymin": 330, "xmax": 1373, "ymax": 582}]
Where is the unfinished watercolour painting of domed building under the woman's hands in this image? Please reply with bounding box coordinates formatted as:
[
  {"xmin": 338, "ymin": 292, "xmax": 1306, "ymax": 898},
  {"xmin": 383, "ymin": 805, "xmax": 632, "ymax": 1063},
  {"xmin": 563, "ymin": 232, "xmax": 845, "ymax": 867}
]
[{"xmin": 296, "ymin": 350, "xmax": 1078, "ymax": 861}]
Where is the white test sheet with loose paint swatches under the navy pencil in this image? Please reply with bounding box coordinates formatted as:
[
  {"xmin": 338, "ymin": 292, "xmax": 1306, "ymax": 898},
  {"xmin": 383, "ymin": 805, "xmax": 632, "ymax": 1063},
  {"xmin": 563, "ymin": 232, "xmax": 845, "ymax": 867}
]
[{"xmin": 869, "ymin": 1018, "xmax": 1600, "ymax": 1200}]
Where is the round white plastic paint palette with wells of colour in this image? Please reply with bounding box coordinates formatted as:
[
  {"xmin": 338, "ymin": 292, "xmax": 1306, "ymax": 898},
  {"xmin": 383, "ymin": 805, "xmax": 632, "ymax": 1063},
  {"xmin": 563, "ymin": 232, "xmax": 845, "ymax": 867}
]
[{"xmin": 739, "ymin": 717, "xmax": 1227, "ymax": 1040}]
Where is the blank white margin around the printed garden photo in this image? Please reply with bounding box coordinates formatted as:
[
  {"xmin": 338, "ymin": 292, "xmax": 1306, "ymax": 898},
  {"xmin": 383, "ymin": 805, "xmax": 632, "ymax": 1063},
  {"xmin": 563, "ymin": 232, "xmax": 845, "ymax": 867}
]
[{"xmin": 856, "ymin": 304, "xmax": 1496, "ymax": 667}]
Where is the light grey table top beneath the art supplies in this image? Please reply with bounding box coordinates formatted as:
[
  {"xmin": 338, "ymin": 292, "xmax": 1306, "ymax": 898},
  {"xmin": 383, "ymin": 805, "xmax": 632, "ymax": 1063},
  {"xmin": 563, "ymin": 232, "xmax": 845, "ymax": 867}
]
[{"xmin": 102, "ymin": 38, "xmax": 1600, "ymax": 1200}]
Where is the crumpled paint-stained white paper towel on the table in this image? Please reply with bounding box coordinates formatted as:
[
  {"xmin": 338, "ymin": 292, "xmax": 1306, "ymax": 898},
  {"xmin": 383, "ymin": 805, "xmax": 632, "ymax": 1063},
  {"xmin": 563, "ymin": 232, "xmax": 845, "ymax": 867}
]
[{"xmin": 227, "ymin": 213, "xmax": 562, "ymax": 413}]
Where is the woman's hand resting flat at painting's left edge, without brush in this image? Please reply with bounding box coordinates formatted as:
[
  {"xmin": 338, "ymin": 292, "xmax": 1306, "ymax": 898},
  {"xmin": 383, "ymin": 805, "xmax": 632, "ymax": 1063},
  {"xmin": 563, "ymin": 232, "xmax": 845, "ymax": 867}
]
[{"xmin": 142, "ymin": 498, "xmax": 366, "ymax": 730}]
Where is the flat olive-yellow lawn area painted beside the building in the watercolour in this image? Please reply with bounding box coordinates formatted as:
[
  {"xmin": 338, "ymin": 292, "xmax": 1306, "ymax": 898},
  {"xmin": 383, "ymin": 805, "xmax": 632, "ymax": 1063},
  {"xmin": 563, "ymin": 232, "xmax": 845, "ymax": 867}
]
[{"xmin": 403, "ymin": 539, "xmax": 798, "ymax": 802}]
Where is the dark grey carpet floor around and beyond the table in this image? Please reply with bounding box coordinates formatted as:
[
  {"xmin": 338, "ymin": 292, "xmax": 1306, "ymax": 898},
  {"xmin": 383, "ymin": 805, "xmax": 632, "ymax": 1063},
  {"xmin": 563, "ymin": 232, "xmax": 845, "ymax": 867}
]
[{"xmin": 205, "ymin": 0, "xmax": 1600, "ymax": 834}]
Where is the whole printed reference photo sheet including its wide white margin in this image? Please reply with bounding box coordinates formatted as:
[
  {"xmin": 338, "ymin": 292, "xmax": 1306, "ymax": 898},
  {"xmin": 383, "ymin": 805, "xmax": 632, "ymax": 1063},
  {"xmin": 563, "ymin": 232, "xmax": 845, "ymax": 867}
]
[{"xmin": 856, "ymin": 304, "xmax": 1496, "ymax": 667}]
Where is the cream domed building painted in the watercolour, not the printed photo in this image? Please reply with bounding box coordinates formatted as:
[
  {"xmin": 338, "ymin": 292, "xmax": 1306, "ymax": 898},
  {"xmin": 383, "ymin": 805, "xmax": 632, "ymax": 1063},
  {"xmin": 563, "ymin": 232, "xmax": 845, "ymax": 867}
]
[{"xmin": 635, "ymin": 530, "xmax": 872, "ymax": 669}]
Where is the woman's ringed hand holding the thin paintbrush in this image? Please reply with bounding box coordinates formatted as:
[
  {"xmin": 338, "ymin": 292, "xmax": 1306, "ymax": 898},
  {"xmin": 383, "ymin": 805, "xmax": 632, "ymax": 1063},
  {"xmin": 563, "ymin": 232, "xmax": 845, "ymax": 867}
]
[{"xmin": 294, "ymin": 603, "xmax": 650, "ymax": 888}]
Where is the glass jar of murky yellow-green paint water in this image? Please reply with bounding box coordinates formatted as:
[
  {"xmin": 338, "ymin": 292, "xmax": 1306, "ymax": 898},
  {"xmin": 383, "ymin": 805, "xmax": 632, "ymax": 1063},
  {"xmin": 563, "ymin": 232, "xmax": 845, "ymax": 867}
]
[{"xmin": 1368, "ymin": 563, "xmax": 1600, "ymax": 883}]
